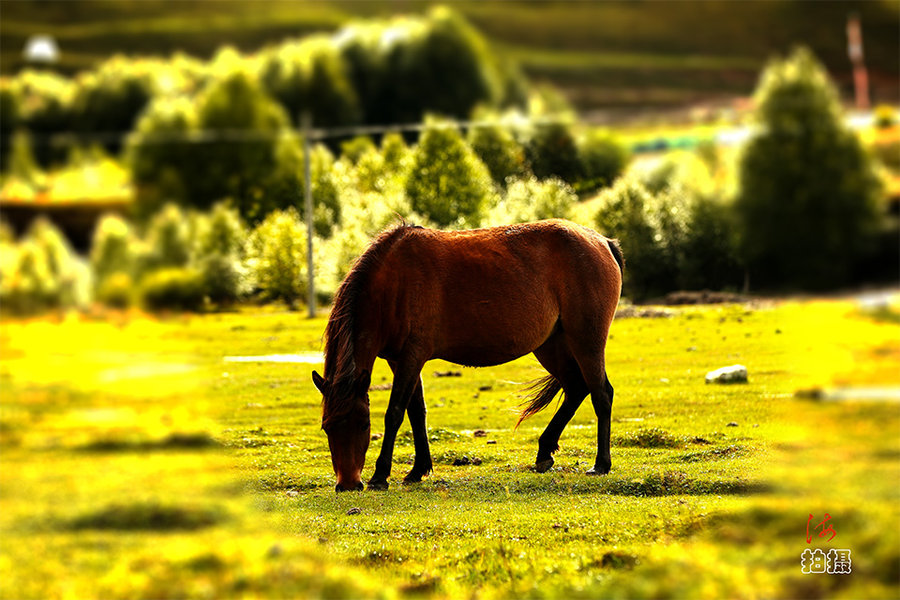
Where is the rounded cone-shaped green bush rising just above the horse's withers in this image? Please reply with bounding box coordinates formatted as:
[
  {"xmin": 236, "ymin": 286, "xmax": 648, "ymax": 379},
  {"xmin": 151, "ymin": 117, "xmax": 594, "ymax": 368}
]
[{"xmin": 406, "ymin": 120, "xmax": 491, "ymax": 227}]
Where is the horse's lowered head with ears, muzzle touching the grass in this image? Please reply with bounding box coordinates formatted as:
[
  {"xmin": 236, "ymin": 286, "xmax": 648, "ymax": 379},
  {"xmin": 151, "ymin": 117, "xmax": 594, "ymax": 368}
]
[{"xmin": 313, "ymin": 371, "xmax": 371, "ymax": 492}]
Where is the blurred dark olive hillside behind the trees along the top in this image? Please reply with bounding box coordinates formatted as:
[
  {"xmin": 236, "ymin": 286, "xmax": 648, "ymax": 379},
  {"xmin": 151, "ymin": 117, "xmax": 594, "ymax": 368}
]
[{"xmin": 0, "ymin": 0, "xmax": 900, "ymax": 117}]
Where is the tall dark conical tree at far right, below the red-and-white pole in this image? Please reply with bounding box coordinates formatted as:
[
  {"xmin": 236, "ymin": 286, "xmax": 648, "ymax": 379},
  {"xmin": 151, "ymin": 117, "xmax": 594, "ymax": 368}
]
[{"xmin": 736, "ymin": 49, "xmax": 879, "ymax": 289}]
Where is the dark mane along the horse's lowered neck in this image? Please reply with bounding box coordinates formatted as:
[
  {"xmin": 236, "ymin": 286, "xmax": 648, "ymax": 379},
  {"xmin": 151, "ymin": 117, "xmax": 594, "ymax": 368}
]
[{"xmin": 322, "ymin": 221, "xmax": 416, "ymax": 425}]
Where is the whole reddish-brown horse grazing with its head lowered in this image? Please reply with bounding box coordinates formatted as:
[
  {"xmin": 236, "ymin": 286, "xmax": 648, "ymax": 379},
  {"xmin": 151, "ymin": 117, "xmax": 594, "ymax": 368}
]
[{"xmin": 312, "ymin": 220, "xmax": 623, "ymax": 491}]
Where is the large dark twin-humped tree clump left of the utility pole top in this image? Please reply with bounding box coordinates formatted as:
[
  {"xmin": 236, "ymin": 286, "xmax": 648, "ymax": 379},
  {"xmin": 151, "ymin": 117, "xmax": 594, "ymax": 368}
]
[{"xmin": 129, "ymin": 68, "xmax": 288, "ymax": 218}]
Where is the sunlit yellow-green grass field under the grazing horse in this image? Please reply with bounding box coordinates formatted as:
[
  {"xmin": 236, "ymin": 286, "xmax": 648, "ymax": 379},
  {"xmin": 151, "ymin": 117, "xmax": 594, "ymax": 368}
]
[{"xmin": 0, "ymin": 297, "xmax": 900, "ymax": 598}]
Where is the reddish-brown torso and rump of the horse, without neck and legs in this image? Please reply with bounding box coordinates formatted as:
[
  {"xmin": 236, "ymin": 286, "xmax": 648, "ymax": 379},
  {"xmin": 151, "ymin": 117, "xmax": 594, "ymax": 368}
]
[{"xmin": 376, "ymin": 220, "xmax": 621, "ymax": 365}]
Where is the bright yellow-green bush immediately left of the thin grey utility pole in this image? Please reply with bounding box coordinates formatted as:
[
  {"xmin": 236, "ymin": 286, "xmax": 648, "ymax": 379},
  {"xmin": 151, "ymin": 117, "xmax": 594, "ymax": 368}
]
[{"xmin": 247, "ymin": 209, "xmax": 308, "ymax": 305}]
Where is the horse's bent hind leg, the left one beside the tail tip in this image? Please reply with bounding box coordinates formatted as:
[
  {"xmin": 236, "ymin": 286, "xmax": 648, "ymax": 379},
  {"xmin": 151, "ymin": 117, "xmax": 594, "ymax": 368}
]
[{"xmin": 534, "ymin": 331, "xmax": 588, "ymax": 473}]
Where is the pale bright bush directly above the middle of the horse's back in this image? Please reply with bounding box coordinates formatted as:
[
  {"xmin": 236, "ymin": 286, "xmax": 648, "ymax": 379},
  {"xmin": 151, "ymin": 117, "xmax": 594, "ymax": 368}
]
[{"xmin": 487, "ymin": 177, "xmax": 578, "ymax": 225}]
